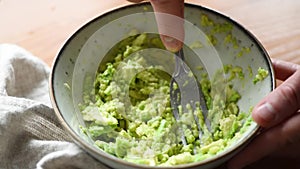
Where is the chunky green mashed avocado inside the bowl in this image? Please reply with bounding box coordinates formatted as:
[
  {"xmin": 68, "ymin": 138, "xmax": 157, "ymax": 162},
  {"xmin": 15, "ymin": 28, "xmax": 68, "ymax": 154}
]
[{"xmin": 81, "ymin": 31, "xmax": 266, "ymax": 166}]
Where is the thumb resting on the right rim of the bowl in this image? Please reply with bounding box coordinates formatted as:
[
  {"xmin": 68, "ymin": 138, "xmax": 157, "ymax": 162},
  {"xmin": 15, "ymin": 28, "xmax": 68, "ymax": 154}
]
[{"xmin": 252, "ymin": 69, "xmax": 300, "ymax": 128}]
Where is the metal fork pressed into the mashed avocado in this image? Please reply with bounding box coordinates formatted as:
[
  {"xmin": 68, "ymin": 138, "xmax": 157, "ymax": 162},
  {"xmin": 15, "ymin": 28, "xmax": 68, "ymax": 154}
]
[{"xmin": 170, "ymin": 49, "xmax": 209, "ymax": 145}]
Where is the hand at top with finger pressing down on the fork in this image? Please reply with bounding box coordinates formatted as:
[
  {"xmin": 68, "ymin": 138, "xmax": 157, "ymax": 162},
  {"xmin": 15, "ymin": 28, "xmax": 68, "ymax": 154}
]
[{"xmin": 128, "ymin": 0, "xmax": 184, "ymax": 52}]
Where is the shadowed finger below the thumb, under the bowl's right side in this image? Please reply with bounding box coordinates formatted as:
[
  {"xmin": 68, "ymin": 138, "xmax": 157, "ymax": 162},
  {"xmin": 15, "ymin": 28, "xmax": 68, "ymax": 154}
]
[{"xmin": 228, "ymin": 113, "xmax": 300, "ymax": 169}]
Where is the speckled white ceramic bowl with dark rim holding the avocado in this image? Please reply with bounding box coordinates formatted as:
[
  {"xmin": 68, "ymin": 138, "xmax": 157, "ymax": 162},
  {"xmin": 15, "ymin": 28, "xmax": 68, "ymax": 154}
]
[{"xmin": 50, "ymin": 3, "xmax": 275, "ymax": 169}]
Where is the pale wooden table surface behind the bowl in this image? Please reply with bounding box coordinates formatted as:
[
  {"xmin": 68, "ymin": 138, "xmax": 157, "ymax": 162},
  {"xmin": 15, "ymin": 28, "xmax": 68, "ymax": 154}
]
[{"xmin": 0, "ymin": 0, "xmax": 300, "ymax": 169}]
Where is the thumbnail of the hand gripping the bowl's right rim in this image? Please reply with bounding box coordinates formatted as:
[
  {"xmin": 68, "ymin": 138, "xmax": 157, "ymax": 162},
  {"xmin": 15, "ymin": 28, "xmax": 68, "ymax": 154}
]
[{"xmin": 257, "ymin": 103, "xmax": 275, "ymax": 121}]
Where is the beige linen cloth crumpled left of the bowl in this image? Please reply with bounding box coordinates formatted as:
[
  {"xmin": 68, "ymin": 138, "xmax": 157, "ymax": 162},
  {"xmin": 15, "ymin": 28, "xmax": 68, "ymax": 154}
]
[{"xmin": 0, "ymin": 44, "xmax": 107, "ymax": 169}]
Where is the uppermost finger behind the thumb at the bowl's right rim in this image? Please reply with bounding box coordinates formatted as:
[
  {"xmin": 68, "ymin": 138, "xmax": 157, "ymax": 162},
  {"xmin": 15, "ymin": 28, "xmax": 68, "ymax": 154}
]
[{"xmin": 272, "ymin": 59, "xmax": 300, "ymax": 81}]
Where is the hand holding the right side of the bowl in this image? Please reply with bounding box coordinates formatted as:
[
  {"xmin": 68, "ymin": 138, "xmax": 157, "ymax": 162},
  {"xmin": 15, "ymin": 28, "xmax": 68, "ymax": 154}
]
[{"xmin": 228, "ymin": 60, "xmax": 300, "ymax": 169}]
